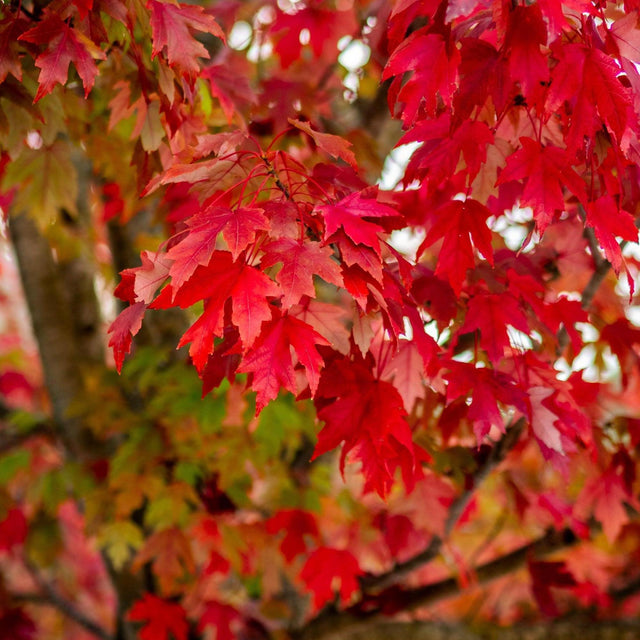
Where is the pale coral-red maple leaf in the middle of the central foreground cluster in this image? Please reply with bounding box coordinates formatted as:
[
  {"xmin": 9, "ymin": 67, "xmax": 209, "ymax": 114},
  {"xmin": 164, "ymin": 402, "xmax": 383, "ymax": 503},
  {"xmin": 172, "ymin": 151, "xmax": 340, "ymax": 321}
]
[{"xmin": 261, "ymin": 238, "xmax": 343, "ymax": 309}]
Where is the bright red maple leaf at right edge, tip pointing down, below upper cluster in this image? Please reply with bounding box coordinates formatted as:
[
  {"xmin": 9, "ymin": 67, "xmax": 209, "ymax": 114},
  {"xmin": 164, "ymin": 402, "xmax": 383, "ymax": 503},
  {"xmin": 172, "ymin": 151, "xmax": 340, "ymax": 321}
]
[{"xmin": 585, "ymin": 195, "xmax": 638, "ymax": 273}]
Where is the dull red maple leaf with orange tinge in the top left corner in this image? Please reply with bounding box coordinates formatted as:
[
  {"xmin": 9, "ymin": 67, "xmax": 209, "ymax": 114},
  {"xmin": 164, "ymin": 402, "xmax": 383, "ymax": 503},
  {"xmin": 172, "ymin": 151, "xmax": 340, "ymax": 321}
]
[{"xmin": 19, "ymin": 13, "xmax": 106, "ymax": 102}]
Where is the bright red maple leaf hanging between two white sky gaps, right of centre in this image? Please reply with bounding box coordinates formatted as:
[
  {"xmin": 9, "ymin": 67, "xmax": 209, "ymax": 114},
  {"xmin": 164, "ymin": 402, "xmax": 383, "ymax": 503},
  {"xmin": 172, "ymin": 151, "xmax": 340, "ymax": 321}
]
[{"xmin": 418, "ymin": 198, "xmax": 493, "ymax": 295}]
